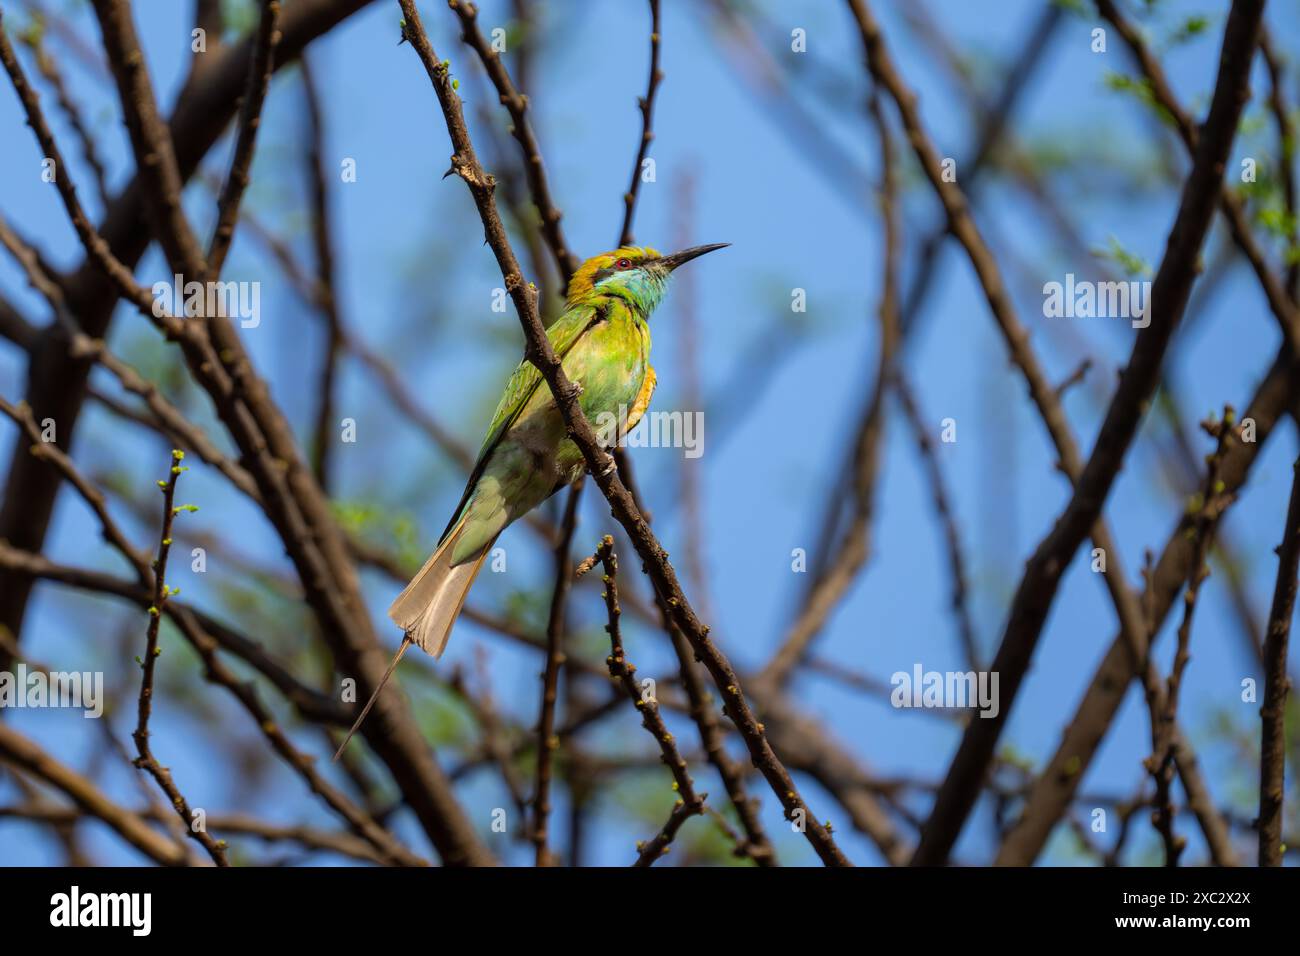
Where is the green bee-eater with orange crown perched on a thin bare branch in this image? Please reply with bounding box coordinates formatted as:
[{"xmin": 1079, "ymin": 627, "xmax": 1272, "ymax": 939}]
[{"xmin": 339, "ymin": 242, "xmax": 729, "ymax": 750}]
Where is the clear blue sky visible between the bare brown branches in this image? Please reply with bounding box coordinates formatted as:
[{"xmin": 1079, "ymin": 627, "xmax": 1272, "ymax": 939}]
[{"xmin": 0, "ymin": 0, "xmax": 1296, "ymax": 864}]
